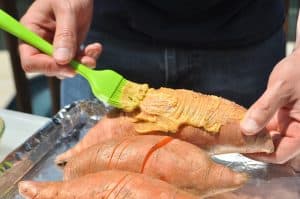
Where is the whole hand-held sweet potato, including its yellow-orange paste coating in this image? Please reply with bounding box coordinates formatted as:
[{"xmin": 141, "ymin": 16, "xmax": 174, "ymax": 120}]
[{"xmin": 56, "ymin": 88, "xmax": 274, "ymax": 163}]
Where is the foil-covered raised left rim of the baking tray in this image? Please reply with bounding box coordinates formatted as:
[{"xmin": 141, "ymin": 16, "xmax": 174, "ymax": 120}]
[{"xmin": 0, "ymin": 99, "xmax": 110, "ymax": 198}]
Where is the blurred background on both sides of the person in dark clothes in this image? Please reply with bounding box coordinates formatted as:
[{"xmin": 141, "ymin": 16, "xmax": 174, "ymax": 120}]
[{"xmin": 0, "ymin": 0, "xmax": 300, "ymax": 117}]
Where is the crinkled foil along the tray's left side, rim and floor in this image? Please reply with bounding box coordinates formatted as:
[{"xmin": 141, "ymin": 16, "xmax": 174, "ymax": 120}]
[{"xmin": 0, "ymin": 100, "xmax": 110, "ymax": 199}]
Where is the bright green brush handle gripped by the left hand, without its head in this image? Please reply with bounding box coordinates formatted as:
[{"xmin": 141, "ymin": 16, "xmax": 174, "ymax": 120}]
[{"xmin": 0, "ymin": 9, "xmax": 91, "ymax": 77}]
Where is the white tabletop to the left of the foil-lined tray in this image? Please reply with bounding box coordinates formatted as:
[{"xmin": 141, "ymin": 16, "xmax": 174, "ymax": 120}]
[{"xmin": 0, "ymin": 109, "xmax": 50, "ymax": 162}]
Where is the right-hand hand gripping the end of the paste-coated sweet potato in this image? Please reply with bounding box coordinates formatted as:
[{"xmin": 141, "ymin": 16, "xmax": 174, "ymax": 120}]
[{"xmin": 241, "ymin": 11, "xmax": 300, "ymax": 163}]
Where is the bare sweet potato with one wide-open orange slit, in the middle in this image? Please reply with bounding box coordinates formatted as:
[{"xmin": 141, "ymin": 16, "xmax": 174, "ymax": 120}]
[{"xmin": 64, "ymin": 135, "xmax": 248, "ymax": 196}]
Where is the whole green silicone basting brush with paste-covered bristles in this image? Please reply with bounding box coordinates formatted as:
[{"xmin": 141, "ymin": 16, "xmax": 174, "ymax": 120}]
[{"xmin": 0, "ymin": 9, "xmax": 148, "ymax": 111}]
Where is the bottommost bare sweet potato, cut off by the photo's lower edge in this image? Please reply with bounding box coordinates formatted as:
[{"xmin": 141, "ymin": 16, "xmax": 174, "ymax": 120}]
[{"xmin": 19, "ymin": 170, "xmax": 199, "ymax": 199}]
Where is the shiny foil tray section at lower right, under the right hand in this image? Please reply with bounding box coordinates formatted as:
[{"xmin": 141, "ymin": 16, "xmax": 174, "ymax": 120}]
[{"xmin": 213, "ymin": 154, "xmax": 300, "ymax": 199}]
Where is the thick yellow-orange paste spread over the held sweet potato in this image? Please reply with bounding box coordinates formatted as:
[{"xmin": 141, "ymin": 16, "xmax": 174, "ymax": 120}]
[{"xmin": 130, "ymin": 88, "xmax": 246, "ymax": 133}]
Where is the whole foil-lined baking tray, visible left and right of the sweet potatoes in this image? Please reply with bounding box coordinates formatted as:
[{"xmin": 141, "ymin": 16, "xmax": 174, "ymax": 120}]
[{"xmin": 0, "ymin": 100, "xmax": 300, "ymax": 199}]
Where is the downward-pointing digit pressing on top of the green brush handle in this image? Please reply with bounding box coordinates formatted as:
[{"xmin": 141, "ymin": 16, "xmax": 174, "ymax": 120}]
[{"xmin": 53, "ymin": 9, "xmax": 77, "ymax": 65}]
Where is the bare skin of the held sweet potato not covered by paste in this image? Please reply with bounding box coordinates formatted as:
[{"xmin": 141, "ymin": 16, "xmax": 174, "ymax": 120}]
[{"xmin": 56, "ymin": 111, "xmax": 274, "ymax": 164}]
